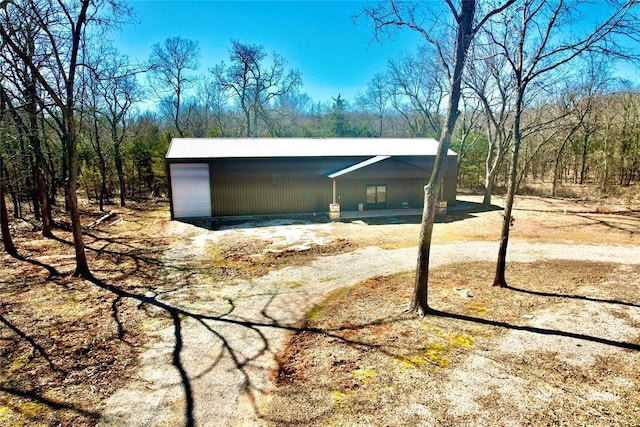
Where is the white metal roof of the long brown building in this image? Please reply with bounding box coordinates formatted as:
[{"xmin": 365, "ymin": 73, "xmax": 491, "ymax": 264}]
[{"xmin": 166, "ymin": 138, "xmax": 456, "ymax": 160}]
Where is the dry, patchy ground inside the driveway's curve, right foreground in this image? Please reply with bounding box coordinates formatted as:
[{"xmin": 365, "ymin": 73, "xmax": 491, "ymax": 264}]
[{"xmin": 265, "ymin": 261, "xmax": 640, "ymax": 426}]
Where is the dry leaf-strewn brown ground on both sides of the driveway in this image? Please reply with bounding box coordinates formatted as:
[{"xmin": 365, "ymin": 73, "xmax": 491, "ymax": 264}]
[{"xmin": 0, "ymin": 193, "xmax": 640, "ymax": 425}]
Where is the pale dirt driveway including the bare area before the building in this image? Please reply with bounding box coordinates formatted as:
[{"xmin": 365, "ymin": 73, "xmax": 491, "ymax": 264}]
[{"xmin": 100, "ymin": 199, "xmax": 640, "ymax": 426}]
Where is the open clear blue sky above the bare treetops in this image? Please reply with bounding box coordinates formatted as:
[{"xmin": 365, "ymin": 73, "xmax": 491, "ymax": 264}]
[{"xmin": 112, "ymin": 0, "xmax": 420, "ymax": 102}]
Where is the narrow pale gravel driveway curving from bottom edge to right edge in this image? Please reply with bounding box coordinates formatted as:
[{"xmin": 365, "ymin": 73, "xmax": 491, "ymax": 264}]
[{"xmin": 101, "ymin": 223, "xmax": 640, "ymax": 426}]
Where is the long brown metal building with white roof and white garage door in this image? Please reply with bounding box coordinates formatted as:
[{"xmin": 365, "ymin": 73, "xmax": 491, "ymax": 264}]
[{"xmin": 166, "ymin": 138, "xmax": 457, "ymax": 219}]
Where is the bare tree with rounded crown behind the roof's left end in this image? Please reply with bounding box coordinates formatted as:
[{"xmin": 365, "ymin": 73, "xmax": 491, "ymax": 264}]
[{"xmin": 149, "ymin": 37, "xmax": 200, "ymax": 137}]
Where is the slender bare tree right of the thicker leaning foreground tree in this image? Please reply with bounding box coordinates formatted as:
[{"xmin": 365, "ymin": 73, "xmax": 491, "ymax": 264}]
[{"xmin": 488, "ymin": 0, "xmax": 638, "ymax": 287}]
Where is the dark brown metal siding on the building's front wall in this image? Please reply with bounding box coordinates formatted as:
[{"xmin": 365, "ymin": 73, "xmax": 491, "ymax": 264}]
[{"xmin": 170, "ymin": 156, "xmax": 457, "ymax": 216}]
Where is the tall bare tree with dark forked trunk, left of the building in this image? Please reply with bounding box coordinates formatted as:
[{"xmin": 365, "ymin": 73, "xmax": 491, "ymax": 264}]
[{"xmin": 0, "ymin": 0, "xmax": 128, "ymax": 277}]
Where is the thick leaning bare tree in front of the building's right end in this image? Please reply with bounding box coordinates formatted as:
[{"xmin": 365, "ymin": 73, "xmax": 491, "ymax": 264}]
[{"xmin": 362, "ymin": 0, "xmax": 515, "ymax": 315}]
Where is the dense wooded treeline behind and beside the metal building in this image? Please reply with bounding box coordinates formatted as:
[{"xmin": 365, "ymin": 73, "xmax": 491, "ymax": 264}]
[{"xmin": 0, "ymin": 0, "xmax": 640, "ymax": 274}]
